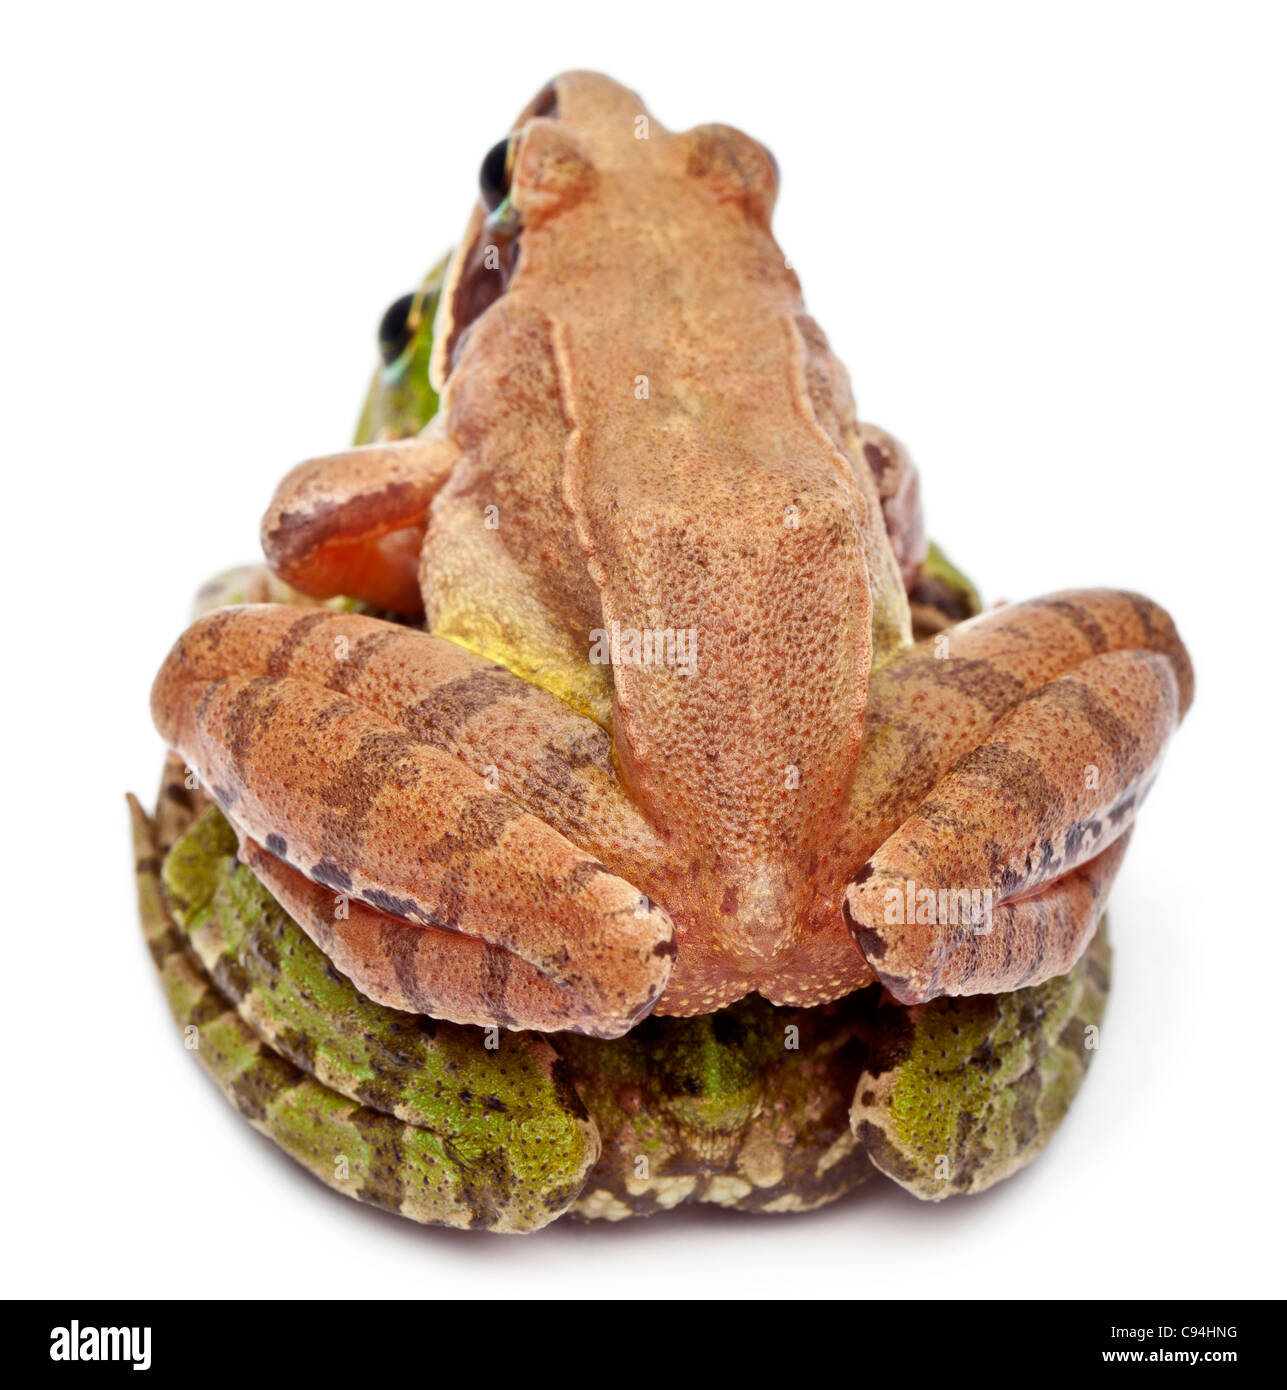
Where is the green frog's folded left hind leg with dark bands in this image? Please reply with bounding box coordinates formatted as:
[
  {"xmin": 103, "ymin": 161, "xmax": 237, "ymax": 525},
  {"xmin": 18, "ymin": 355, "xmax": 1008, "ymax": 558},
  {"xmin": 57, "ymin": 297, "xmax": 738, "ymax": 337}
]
[{"xmin": 131, "ymin": 798, "xmax": 599, "ymax": 1232}]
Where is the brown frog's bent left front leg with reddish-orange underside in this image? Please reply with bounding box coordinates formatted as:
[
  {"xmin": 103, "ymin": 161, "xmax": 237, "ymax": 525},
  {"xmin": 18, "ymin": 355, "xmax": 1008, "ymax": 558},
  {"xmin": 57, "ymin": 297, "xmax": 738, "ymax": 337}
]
[{"xmin": 260, "ymin": 425, "xmax": 457, "ymax": 616}]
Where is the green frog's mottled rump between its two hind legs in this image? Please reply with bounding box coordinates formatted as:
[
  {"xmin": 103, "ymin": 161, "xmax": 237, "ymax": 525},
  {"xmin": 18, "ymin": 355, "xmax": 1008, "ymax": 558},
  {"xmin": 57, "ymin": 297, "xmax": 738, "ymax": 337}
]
[{"xmin": 557, "ymin": 991, "xmax": 874, "ymax": 1219}]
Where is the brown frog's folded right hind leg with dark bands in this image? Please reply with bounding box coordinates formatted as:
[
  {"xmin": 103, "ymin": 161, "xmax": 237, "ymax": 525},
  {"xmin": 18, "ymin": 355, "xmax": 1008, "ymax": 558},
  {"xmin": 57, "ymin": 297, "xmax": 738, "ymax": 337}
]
[{"xmin": 845, "ymin": 591, "xmax": 1192, "ymax": 1004}]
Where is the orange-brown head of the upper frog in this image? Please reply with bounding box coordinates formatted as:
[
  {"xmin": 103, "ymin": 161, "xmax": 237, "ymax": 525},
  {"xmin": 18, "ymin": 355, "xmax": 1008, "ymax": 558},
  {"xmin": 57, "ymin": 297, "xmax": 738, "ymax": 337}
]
[{"xmin": 429, "ymin": 72, "xmax": 794, "ymax": 391}]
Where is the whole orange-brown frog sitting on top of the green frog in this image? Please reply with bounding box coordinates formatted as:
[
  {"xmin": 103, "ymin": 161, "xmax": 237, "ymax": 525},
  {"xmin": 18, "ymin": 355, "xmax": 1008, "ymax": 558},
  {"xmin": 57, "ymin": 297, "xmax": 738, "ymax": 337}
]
[{"xmin": 154, "ymin": 74, "xmax": 1192, "ymax": 1036}]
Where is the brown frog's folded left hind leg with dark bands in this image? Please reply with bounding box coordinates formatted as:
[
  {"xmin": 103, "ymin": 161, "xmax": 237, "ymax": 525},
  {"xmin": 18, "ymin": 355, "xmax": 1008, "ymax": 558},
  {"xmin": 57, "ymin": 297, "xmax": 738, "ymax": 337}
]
[{"xmin": 153, "ymin": 605, "xmax": 675, "ymax": 1037}]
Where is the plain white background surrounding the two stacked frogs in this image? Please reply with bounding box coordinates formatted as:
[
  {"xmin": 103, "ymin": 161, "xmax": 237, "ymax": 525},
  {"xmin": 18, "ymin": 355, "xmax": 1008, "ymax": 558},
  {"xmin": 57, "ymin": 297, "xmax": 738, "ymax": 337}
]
[{"xmin": 0, "ymin": 0, "xmax": 1287, "ymax": 1298}]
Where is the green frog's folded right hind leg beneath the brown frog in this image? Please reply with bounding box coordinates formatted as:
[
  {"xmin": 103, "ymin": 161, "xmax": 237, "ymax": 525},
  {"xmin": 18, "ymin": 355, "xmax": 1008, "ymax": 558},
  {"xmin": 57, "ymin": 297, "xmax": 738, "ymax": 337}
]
[{"xmin": 852, "ymin": 922, "xmax": 1110, "ymax": 1201}]
